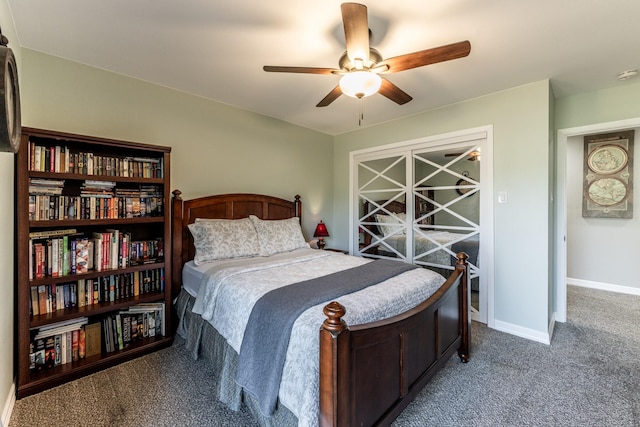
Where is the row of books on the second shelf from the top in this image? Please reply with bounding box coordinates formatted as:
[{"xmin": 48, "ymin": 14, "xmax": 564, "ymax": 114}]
[{"xmin": 29, "ymin": 179, "xmax": 164, "ymax": 221}]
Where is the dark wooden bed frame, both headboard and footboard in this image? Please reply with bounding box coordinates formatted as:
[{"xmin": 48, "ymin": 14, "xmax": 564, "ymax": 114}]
[{"xmin": 172, "ymin": 190, "xmax": 471, "ymax": 427}]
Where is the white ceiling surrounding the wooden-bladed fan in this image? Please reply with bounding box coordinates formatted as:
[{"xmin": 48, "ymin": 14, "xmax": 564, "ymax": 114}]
[{"xmin": 8, "ymin": 0, "xmax": 640, "ymax": 135}]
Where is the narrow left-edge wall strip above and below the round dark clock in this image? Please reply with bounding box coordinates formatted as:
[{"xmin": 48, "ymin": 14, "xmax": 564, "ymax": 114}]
[{"xmin": 0, "ymin": 0, "xmax": 18, "ymax": 418}]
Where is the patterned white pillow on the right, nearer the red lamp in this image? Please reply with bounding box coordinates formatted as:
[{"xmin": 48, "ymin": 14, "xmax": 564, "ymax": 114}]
[{"xmin": 249, "ymin": 215, "xmax": 309, "ymax": 256}]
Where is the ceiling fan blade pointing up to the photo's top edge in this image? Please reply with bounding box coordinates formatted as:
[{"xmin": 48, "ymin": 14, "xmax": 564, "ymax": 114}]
[{"xmin": 340, "ymin": 3, "xmax": 369, "ymax": 64}]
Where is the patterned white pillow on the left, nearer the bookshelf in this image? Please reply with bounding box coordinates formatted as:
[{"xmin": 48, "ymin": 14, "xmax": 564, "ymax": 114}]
[{"xmin": 188, "ymin": 218, "xmax": 260, "ymax": 265}]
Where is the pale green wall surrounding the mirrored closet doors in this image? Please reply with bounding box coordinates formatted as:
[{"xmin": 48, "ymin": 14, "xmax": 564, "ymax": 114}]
[{"xmin": 333, "ymin": 80, "xmax": 550, "ymax": 334}]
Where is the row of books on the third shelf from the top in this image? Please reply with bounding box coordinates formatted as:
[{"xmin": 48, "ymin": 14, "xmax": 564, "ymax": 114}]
[{"xmin": 29, "ymin": 228, "xmax": 164, "ymax": 280}]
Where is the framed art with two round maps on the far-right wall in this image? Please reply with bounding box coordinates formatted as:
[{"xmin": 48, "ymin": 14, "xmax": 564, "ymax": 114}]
[{"xmin": 582, "ymin": 130, "xmax": 634, "ymax": 218}]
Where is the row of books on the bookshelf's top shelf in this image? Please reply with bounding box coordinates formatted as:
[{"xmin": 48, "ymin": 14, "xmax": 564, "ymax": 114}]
[{"xmin": 29, "ymin": 142, "xmax": 164, "ymax": 178}]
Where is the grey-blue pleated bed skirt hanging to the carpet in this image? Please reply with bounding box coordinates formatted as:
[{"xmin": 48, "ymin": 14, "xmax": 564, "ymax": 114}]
[{"xmin": 174, "ymin": 289, "xmax": 298, "ymax": 427}]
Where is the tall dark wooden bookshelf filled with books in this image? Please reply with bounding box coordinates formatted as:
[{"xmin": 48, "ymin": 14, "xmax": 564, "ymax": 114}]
[{"xmin": 15, "ymin": 128, "xmax": 172, "ymax": 398}]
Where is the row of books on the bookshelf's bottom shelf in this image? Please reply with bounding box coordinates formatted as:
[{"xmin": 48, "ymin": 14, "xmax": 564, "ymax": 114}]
[{"xmin": 29, "ymin": 302, "xmax": 165, "ymax": 371}]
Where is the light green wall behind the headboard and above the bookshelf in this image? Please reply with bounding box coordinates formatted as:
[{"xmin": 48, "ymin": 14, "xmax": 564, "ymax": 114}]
[{"xmin": 23, "ymin": 49, "xmax": 333, "ymax": 238}]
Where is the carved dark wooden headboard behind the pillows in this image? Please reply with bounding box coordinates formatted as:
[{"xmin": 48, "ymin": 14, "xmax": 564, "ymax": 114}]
[{"xmin": 171, "ymin": 190, "xmax": 302, "ymax": 296}]
